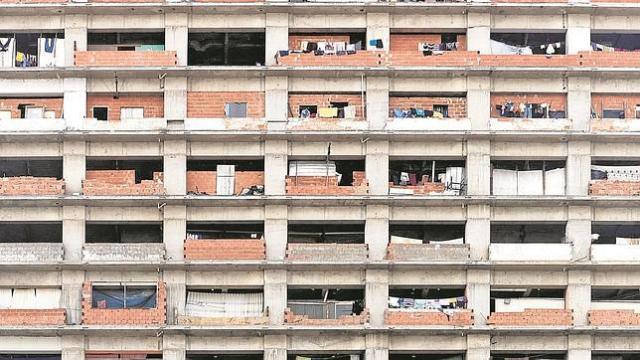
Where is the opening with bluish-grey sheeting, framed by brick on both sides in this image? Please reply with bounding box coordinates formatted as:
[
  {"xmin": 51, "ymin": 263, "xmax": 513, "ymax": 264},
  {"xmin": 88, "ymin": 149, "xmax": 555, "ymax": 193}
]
[{"xmin": 91, "ymin": 284, "xmax": 158, "ymax": 309}]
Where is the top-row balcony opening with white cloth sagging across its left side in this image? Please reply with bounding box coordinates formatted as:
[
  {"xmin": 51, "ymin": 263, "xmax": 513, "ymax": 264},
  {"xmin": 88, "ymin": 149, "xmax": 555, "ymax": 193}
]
[{"xmin": 491, "ymin": 32, "xmax": 566, "ymax": 56}]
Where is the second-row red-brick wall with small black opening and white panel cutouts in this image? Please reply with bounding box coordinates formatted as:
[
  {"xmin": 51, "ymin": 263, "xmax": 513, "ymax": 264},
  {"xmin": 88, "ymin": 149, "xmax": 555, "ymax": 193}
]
[{"xmin": 87, "ymin": 94, "xmax": 164, "ymax": 121}]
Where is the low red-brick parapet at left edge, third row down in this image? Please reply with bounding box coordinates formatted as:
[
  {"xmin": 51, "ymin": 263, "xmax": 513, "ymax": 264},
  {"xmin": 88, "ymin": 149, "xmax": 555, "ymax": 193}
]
[{"xmin": 0, "ymin": 176, "xmax": 64, "ymax": 196}]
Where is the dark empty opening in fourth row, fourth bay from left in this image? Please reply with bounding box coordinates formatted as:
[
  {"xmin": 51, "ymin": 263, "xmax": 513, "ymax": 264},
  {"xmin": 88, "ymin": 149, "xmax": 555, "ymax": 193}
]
[{"xmin": 288, "ymin": 223, "xmax": 364, "ymax": 244}]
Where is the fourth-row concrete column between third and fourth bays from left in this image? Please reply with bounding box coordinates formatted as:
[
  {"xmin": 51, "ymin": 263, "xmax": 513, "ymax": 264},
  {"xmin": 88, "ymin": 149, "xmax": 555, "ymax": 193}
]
[{"xmin": 264, "ymin": 205, "xmax": 288, "ymax": 261}]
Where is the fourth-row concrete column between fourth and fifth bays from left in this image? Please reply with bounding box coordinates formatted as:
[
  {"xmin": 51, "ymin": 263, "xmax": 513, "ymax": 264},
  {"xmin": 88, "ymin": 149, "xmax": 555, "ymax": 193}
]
[{"xmin": 364, "ymin": 205, "xmax": 389, "ymax": 261}]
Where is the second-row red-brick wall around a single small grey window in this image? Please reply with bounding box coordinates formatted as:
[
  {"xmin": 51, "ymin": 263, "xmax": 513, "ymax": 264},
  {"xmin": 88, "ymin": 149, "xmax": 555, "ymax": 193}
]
[{"xmin": 187, "ymin": 91, "xmax": 264, "ymax": 118}]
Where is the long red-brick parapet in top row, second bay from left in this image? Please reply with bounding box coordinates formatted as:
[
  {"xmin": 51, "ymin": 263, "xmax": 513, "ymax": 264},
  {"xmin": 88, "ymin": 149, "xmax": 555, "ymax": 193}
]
[{"xmin": 74, "ymin": 51, "xmax": 178, "ymax": 67}]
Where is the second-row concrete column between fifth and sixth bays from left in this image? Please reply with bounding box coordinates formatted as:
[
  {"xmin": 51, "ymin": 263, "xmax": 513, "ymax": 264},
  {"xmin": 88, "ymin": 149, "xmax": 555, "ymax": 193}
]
[{"xmin": 467, "ymin": 76, "xmax": 491, "ymax": 130}]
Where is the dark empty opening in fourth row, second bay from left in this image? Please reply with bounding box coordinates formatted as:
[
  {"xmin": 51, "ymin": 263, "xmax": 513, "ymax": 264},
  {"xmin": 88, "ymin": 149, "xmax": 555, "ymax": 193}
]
[{"xmin": 85, "ymin": 222, "xmax": 162, "ymax": 244}]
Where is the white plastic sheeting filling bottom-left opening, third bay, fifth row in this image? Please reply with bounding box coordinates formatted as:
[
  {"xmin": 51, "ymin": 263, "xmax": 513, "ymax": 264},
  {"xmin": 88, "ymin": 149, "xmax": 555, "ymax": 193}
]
[{"xmin": 185, "ymin": 291, "xmax": 264, "ymax": 317}]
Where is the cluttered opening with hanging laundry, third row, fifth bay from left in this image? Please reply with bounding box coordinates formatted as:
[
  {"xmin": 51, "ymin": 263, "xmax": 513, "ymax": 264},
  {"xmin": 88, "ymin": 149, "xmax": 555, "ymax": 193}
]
[{"xmin": 389, "ymin": 159, "xmax": 466, "ymax": 195}]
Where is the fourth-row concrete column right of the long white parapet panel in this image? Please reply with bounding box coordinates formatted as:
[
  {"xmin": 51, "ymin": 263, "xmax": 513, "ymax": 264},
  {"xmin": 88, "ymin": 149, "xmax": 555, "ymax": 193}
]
[{"xmin": 565, "ymin": 206, "xmax": 591, "ymax": 262}]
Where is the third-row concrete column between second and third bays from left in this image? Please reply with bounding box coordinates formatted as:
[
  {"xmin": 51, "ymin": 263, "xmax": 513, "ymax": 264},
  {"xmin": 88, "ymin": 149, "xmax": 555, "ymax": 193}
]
[{"xmin": 163, "ymin": 140, "xmax": 187, "ymax": 195}]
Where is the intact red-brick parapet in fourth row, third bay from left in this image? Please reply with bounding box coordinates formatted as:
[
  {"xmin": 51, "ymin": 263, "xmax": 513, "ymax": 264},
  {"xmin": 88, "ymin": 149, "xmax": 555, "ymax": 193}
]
[{"xmin": 184, "ymin": 239, "xmax": 266, "ymax": 260}]
